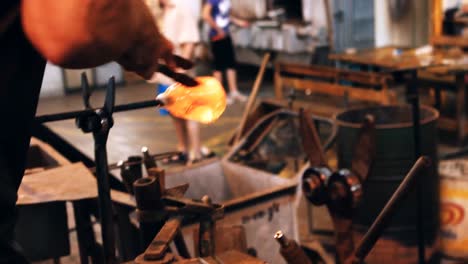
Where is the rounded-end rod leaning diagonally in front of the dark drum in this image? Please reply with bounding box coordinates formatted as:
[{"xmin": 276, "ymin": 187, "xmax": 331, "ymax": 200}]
[{"xmin": 351, "ymin": 156, "xmax": 430, "ymax": 263}]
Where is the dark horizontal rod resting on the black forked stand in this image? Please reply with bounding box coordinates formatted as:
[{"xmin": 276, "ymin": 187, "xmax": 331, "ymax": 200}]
[{"xmin": 35, "ymin": 100, "xmax": 163, "ymax": 123}]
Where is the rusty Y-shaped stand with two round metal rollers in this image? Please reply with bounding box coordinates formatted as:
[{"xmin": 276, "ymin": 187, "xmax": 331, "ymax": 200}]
[{"xmin": 299, "ymin": 109, "xmax": 375, "ymax": 263}]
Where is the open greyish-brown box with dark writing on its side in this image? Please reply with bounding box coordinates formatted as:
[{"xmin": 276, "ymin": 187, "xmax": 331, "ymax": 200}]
[{"xmin": 166, "ymin": 157, "xmax": 296, "ymax": 263}]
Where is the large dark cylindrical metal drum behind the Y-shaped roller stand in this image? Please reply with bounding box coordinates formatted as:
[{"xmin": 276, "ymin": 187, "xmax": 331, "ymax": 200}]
[{"xmin": 335, "ymin": 106, "xmax": 439, "ymax": 263}]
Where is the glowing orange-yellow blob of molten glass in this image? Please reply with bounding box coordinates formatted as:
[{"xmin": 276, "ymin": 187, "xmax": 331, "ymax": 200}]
[{"xmin": 156, "ymin": 76, "xmax": 226, "ymax": 124}]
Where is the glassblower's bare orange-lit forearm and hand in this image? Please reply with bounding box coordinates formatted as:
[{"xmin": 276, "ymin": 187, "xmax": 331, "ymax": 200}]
[{"xmin": 21, "ymin": 0, "xmax": 174, "ymax": 78}]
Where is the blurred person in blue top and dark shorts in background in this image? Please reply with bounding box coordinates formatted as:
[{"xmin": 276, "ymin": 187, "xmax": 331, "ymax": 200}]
[{"xmin": 203, "ymin": 0, "xmax": 249, "ymax": 104}]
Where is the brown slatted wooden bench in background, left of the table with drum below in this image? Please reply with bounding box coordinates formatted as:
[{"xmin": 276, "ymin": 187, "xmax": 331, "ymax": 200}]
[{"xmin": 274, "ymin": 63, "xmax": 396, "ymax": 105}]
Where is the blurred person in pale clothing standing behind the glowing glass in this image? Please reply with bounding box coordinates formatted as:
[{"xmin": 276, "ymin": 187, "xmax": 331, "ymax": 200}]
[{"xmin": 150, "ymin": 0, "xmax": 213, "ymax": 165}]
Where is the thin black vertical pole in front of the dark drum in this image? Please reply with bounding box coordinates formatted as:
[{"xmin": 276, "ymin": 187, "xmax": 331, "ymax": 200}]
[{"xmin": 407, "ymin": 70, "xmax": 425, "ymax": 264}]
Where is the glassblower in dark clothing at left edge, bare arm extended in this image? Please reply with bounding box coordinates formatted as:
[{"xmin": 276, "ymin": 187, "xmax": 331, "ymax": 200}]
[{"xmin": 0, "ymin": 0, "xmax": 176, "ymax": 264}]
